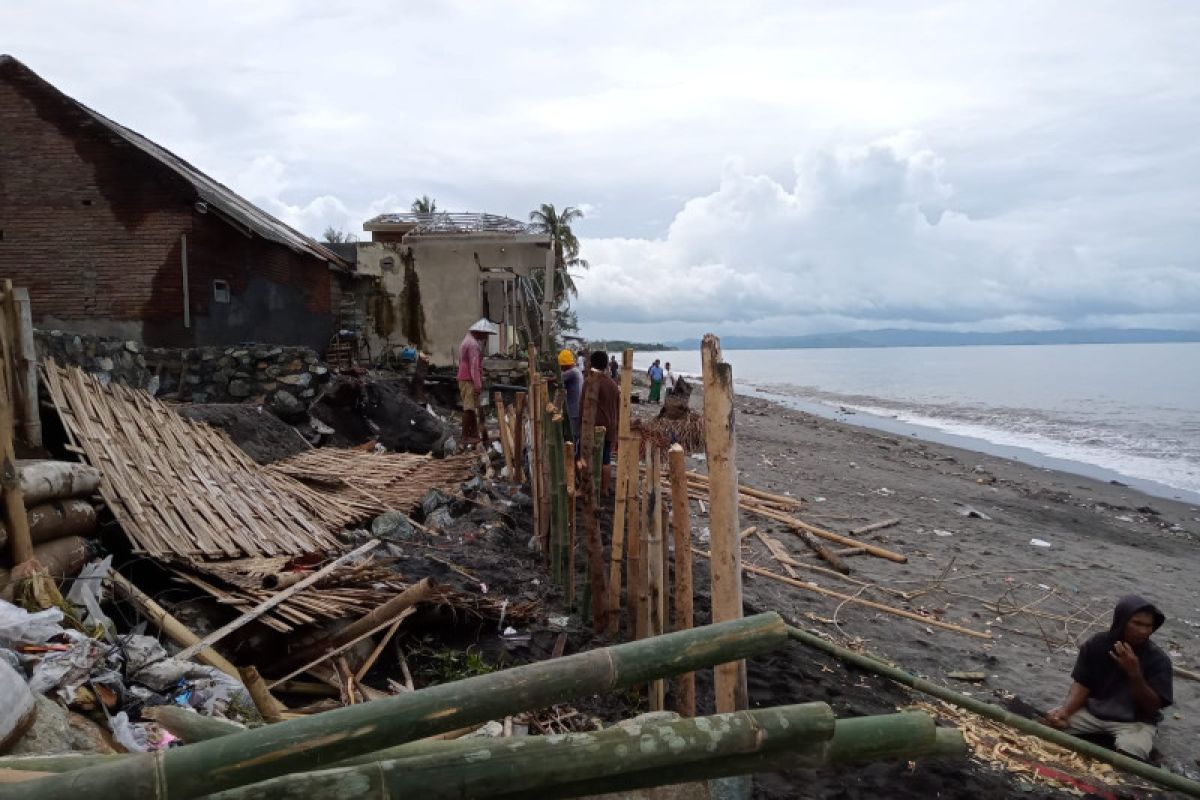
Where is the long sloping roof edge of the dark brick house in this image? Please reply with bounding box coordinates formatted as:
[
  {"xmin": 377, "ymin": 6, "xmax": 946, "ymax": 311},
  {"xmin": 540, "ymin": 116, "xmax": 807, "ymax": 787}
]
[{"xmin": 0, "ymin": 54, "xmax": 348, "ymax": 269}]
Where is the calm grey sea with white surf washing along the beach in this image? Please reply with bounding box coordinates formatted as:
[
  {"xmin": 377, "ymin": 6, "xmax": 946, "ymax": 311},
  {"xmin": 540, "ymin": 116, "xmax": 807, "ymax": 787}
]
[{"xmin": 635, "ymin": 343, "xmax": 1200, "ymax": 501}]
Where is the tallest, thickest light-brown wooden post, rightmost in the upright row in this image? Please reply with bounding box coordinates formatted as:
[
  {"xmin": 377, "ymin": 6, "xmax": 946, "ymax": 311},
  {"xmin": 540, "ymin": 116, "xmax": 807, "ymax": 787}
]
[{"xmin": 700, "ymin": 333, "xmax": 749, "ymax": 712}]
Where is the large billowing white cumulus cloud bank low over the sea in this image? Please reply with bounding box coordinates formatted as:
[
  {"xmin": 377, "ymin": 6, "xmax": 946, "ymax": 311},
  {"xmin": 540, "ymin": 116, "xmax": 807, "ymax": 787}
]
[{"xmin": 577, "ymin": 132, "xmax": 1200, "ymax": 335}]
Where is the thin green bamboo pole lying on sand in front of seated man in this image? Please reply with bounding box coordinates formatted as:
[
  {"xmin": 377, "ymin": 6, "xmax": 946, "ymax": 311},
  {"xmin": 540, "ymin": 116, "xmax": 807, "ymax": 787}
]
[{"xmin": 787, "ymin": 626, "xmax": 1200, "ymax": 798}]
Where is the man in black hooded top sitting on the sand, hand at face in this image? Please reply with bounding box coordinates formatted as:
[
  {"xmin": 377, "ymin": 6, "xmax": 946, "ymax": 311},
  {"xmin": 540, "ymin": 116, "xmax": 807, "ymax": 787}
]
[{"xmin": 1045, "ymin": 595, "xmax": 1171, "ymax": 760}]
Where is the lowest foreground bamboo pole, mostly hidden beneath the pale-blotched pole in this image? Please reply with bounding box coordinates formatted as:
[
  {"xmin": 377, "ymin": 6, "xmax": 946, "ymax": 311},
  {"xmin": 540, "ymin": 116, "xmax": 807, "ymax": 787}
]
[{"xmin": 493, "ymin": 711, "xmax": 967, "ymax": 800}]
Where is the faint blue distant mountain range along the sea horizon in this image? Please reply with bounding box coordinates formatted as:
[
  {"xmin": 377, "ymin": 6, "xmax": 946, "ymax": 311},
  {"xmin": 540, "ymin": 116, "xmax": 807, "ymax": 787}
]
[{"xmin": 668, "ymin": 327, "xmax": 1200, "ymax": 350}]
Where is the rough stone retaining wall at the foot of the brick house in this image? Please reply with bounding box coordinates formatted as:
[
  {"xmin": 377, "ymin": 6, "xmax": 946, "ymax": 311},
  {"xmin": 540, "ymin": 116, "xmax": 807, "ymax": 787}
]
[{"xmin": 34, "ymin": 331, "xmax": 330, "ymax": 403}]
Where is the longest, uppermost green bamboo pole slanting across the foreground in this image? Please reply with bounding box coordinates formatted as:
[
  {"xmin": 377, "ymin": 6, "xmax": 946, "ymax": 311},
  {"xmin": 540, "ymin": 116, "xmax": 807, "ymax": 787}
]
[{"xmin": 5, "ymin": 613, "xmax": 787, "ymax": 800}]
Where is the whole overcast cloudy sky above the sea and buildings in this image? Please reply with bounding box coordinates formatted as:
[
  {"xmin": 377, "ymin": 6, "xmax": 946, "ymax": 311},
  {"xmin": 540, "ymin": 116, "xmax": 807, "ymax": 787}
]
[{"xmin": 9, "ymin": 0, "xmax": 1200, "ymax": 339}]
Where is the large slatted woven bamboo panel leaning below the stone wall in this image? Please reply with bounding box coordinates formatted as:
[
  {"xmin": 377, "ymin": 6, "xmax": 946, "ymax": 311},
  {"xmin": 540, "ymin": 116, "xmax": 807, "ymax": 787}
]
[{"xmin": 44, "ymin": 361, "xmax": 341, "ymax": 559}]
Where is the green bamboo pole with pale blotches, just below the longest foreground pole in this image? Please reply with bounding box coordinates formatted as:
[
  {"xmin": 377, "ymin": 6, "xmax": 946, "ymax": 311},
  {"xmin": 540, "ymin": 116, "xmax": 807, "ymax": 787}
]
[{"xmin": 210, "ymin": 703, "xmax": 834, "ymax": 800}]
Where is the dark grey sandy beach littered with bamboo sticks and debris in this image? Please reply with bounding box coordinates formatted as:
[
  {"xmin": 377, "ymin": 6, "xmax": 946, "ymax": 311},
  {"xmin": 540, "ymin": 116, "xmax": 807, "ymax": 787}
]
[{"xmin": 634, "ymin": 379, "xmax": 1200, "ymax": 798}]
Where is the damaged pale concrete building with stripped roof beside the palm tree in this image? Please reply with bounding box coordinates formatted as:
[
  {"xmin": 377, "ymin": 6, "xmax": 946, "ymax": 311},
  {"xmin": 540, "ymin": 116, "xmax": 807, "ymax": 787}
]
[{"xmin": 355, "ymin": 213, "xmax": 553, "ymax": 366}]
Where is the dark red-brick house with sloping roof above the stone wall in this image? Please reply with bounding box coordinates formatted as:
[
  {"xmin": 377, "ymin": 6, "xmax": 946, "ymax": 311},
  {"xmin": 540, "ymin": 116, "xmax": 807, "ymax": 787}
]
[{"xmin": 0, "ymin": 55, "xmax": 355, "ymax": 350}]
